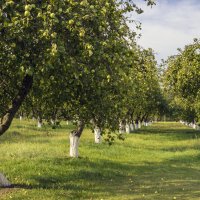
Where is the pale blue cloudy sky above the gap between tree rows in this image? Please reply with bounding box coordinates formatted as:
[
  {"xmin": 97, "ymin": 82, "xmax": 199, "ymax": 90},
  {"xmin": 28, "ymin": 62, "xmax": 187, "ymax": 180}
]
[{"xmin": 131, "ymin": 0, "xmax": 200, "ymax": 63}]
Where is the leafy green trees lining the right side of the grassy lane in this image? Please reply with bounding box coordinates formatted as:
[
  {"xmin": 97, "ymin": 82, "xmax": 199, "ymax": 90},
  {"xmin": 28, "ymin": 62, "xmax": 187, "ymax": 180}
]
[{"xmin": 164, "ymin": 39, "xmax": 200, "ymax": 127}]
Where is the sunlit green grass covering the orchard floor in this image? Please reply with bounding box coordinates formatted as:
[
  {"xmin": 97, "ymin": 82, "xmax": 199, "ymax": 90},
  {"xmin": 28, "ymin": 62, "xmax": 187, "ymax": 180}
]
[{"xmin": 0, "ymin": 120, "xmax": 200, "ymax": 200}]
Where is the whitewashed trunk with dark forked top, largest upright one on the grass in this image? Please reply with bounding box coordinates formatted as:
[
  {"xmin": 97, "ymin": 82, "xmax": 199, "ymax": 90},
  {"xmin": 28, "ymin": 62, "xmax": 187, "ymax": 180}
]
[{"xmin": 69, "ymin": 121, "xmax": 84, "ymax": 158}]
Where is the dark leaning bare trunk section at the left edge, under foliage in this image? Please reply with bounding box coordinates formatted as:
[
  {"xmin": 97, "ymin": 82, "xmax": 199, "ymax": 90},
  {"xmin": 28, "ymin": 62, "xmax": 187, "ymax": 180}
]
[{"xmin": 0, "ymin": 75, "xmax": 33, "ymax": 135}]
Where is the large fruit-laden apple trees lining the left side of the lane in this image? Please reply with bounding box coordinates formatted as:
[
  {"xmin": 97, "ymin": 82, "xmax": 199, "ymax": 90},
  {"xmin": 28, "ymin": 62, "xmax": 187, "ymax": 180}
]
[{"xmin": 0, "ymin": 0, "xmax": 164, "ymax": 157}]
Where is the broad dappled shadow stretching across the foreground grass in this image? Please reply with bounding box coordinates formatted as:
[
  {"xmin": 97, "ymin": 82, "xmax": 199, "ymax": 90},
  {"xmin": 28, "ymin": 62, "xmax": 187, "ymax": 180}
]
[{"xmin": 10, "ymin": 157, "xmax": 200, "ymax": 199}]
